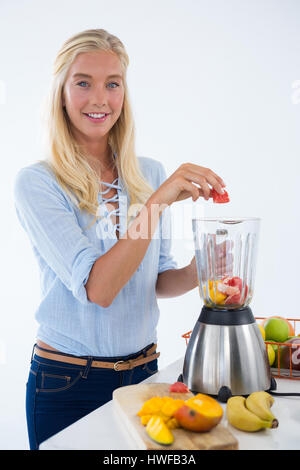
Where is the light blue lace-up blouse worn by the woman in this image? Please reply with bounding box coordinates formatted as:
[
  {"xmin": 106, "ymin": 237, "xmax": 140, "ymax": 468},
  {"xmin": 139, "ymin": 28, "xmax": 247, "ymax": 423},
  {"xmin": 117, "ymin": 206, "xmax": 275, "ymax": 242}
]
[{"xmin": 14, "ymin": 156, "xmax": 177, "ymax": 357}]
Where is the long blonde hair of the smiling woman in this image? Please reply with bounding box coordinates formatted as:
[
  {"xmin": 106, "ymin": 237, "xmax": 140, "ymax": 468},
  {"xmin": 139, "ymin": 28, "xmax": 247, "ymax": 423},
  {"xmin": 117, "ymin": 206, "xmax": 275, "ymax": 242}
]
[{"xmin": 40, "ymin": 29, "xmax": 154, "ymax": 229}]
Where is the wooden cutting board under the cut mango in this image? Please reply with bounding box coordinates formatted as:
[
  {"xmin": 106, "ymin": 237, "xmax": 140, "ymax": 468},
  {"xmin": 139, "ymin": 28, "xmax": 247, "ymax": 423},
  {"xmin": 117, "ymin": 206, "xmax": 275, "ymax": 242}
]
[{"xmin": 113, "ymin": 383, "xmax": 238, "ymax": 450}]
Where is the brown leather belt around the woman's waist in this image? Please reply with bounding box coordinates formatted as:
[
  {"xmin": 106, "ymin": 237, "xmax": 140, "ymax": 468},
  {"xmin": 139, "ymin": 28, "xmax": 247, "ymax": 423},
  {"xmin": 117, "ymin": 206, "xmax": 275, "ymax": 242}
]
[{"xmin": 33, "ymin": 344, "xmax": 160, "ymax": 371}]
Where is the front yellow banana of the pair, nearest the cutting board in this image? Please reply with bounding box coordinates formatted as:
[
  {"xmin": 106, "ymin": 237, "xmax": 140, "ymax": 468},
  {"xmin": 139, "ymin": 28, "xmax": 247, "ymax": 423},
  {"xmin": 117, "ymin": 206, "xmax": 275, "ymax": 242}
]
[{"xmin": 226, "ymin": 396, "xmax": 272, "ymax": 432}]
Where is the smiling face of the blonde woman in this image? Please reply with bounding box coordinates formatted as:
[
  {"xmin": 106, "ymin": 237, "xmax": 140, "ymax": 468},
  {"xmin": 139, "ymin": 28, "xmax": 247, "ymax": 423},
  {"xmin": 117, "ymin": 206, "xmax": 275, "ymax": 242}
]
[{"xmin": 62, "ymin": 51, "xmax": 124, "ymax": 148}]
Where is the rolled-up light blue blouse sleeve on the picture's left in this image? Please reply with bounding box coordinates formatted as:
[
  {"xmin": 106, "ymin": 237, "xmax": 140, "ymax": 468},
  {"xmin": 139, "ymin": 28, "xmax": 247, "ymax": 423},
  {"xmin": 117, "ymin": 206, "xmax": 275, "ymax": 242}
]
[{"xmin": 14, "ymin": 168, "xmax": 101, "ymax": 304}]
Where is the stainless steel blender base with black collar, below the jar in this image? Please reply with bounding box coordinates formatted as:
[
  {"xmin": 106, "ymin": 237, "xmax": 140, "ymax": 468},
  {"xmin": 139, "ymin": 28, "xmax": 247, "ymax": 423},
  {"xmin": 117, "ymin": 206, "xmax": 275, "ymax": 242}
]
[{"xmin": 183, "ymin": 307, "xmax": 271, "ymax": 396}]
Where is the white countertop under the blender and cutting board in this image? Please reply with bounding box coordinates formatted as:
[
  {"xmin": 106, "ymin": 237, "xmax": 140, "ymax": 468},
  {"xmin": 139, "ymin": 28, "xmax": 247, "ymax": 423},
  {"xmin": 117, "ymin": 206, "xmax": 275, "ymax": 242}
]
[{"xmin": 40, "ymin": 358, "xmax": 300, "ymax": 450}]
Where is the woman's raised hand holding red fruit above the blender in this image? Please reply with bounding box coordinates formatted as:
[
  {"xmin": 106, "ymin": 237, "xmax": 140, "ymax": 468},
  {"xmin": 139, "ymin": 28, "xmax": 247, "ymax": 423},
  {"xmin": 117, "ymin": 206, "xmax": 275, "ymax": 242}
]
[{"xmin": 152, "ymin": 163, "xmax": 225, "ymax": 205}]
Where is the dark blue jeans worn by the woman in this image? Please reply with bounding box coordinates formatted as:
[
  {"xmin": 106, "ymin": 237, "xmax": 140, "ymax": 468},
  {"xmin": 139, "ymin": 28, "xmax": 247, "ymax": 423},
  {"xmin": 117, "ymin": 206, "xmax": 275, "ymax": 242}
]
[{"xmin": 26, "ymin": 344, "xmax": 157, "ymax": 450}]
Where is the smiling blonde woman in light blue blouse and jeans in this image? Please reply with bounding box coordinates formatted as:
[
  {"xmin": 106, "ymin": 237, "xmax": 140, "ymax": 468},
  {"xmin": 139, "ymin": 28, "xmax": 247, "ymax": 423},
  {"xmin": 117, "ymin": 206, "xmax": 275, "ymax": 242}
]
[{"xmin": 14, "ymin": 29, "xmax": 225, "ymax": 449}]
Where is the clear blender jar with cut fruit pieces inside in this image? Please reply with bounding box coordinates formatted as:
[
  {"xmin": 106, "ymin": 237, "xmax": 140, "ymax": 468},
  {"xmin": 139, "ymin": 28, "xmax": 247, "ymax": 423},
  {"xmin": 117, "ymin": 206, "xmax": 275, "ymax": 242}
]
[{"xmin": 192, "ymin": 218, "xmax": 260, "ymax": 310}]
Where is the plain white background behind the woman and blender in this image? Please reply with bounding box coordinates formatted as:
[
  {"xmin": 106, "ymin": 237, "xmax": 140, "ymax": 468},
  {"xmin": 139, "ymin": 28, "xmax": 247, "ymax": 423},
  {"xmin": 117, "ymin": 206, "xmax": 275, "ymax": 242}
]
[{"xmin": 0, "ymin": 0, "xmax": 300, "ymax": 449}]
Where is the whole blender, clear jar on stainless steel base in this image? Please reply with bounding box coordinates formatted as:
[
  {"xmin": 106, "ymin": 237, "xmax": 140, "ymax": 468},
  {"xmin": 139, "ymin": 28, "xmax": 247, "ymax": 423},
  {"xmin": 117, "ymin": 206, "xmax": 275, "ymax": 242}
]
[{"xmin": 182, "ymin": 218, "xmax": 272, "ymax": 402}]
